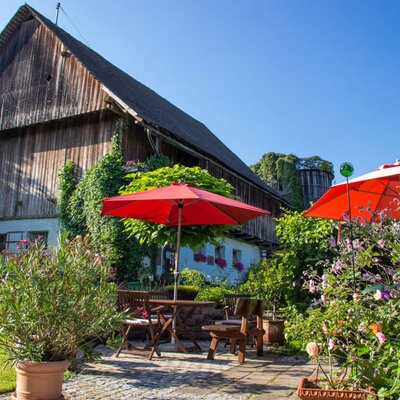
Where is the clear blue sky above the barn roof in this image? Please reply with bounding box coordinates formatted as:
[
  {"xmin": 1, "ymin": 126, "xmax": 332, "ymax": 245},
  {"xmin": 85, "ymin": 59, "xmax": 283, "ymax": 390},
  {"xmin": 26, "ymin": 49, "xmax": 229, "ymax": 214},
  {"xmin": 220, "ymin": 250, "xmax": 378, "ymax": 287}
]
[{"xmin": 0, "ymin": 0, "xmax": 400, "ymax": 182}]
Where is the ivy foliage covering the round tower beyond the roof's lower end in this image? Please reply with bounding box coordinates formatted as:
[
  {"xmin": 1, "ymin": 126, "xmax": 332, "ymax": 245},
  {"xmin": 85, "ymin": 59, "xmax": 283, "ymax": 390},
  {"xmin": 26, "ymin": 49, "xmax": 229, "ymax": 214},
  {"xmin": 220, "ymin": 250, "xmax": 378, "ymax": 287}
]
[{"xmin": 250, "ymin": 152, "xmax": 333, "ymax": 210}]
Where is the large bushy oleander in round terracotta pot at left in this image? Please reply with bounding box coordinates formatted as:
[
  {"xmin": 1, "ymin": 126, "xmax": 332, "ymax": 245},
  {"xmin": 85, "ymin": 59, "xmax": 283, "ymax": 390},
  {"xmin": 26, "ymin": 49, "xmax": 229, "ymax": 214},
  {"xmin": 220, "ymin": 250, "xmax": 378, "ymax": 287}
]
[{"xmin": 0, "ymin": 236, "xmax": 121, "ymax": 400}]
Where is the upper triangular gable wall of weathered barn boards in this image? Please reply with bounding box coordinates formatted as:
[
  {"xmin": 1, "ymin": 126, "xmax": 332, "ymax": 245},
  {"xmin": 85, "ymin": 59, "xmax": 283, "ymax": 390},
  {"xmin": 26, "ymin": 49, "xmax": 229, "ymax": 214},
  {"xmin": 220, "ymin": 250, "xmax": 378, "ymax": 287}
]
[{"xmin": 0, "ymin": 19, "xmax": 105, "ymax": 130}]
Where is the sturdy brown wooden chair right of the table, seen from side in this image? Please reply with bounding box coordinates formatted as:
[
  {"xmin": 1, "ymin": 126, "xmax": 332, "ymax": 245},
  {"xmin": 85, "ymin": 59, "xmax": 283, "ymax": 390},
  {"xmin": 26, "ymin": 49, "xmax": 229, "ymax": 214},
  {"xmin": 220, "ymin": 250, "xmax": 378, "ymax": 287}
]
[{"xmin": 202, "ymin": 298, "xmax": 265, "ymax": 363}]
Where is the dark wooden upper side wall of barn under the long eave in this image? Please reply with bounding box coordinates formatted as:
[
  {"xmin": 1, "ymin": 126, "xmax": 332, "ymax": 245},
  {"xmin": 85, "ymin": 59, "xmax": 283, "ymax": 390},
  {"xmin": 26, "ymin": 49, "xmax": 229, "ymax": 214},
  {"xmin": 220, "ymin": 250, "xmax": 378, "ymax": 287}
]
[{"xmin": 161, "ymin": 142, "xmax": 281, "ymax": 243}]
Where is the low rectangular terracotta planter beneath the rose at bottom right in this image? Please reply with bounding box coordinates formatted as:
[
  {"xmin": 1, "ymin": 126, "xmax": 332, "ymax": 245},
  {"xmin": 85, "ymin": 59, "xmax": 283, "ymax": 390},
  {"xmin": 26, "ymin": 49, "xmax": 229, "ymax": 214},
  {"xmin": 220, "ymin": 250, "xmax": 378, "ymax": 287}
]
[{"xmin": 297, "ymin": 378, "xmax": 377, "ymax": 400}]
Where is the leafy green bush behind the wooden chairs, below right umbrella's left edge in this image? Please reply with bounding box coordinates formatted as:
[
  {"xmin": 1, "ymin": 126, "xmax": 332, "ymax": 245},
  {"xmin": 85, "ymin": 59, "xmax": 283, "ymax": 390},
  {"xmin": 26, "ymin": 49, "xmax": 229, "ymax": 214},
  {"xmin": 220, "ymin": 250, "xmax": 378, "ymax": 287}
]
[{"xmin": 240, "ymin": 210, "xmax": 337, "ymax": 309}]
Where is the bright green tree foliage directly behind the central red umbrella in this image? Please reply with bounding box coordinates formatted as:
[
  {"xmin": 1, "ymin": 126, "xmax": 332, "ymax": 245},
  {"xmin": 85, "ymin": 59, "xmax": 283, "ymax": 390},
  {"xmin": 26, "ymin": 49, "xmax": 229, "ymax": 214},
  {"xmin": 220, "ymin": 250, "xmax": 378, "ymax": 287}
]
[{"xmin": 120, "ymin": 165, "xmax": 234, "ymax": 250}]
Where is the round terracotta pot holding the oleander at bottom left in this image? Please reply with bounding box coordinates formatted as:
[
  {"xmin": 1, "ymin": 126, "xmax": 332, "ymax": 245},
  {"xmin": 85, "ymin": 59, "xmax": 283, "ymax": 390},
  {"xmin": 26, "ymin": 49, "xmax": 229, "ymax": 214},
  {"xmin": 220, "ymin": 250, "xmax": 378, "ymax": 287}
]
[{"xmin": 12, "ymin": 360, "xmax": 69, "ymax": 400}]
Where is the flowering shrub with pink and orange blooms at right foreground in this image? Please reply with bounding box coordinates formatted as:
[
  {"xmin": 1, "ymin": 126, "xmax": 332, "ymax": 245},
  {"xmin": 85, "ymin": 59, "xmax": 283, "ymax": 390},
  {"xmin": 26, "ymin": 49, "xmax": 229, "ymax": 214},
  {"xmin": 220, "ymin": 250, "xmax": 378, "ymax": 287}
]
[{"xmin": 287, "ymin": 221, "xmax": 400, "ymax": 399}]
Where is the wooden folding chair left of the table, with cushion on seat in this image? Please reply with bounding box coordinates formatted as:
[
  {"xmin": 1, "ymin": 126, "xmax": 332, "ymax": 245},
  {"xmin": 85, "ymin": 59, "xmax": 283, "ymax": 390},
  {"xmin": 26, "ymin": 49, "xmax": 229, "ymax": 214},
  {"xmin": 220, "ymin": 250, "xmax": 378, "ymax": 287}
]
[{"xmin": 116, "ymin": 290, "xmax": 162, "ymax": 360}]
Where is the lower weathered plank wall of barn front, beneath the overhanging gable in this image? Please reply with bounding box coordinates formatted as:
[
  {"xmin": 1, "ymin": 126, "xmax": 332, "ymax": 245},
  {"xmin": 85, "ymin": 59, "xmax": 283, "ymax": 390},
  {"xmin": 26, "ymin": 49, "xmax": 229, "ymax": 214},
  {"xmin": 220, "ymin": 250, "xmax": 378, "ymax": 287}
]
[{"xmin": 0, "ymin": 112, "xmax": 115, "ymax": 219}]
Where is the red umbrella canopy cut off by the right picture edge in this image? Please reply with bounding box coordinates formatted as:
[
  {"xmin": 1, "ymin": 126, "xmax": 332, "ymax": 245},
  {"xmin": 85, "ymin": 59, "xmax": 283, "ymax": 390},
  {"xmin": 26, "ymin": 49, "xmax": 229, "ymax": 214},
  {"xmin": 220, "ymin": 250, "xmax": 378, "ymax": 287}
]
[{"xmin": 304, "ymin": 163, "xmax": 400, "ymax": 222}]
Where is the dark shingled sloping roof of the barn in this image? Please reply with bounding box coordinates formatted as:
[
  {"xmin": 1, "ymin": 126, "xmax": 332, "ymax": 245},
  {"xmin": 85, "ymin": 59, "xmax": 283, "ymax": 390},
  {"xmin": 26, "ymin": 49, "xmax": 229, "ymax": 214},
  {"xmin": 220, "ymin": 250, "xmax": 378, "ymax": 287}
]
[{"xmin": 0, "ymin": 5, "xmax": 287, "ymax": 203}]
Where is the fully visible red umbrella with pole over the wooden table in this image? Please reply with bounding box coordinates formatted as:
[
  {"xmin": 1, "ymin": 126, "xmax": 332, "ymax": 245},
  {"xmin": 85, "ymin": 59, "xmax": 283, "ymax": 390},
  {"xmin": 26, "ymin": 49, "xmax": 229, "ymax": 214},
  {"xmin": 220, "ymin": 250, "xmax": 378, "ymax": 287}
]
[{"xmin": 102, "ymin": 183, "xmax": 270, "ymax": 300}]
